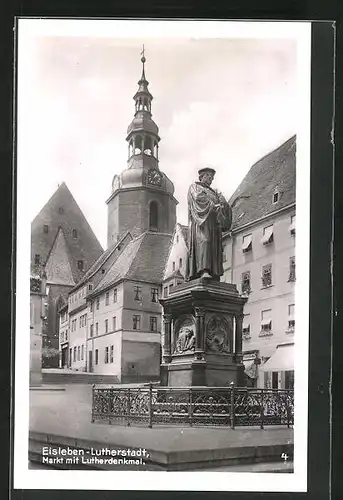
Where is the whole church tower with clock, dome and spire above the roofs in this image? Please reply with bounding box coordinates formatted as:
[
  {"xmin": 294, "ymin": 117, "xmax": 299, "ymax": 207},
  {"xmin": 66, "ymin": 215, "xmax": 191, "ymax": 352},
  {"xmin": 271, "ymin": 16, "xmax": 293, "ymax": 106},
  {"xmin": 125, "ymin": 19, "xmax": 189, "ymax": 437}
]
[{"xmin": 106, "ymin": 46, "xmax": 177, "ymax": 248}]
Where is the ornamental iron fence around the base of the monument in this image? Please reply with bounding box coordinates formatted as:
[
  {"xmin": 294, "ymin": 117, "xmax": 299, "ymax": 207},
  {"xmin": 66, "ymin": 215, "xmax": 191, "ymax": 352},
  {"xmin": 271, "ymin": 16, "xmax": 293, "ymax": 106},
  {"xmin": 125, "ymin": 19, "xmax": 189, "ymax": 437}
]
[{"xmin": 92, "ymin": 384, "xmax": 294, "ymax": 429}]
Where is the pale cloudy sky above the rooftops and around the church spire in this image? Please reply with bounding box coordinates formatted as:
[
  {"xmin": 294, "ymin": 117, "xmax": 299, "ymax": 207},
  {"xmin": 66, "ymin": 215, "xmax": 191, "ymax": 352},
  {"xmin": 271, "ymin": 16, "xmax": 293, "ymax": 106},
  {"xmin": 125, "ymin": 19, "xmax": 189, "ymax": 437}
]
[{"xmin": 18, "ymin": 22, "xmax": 297, "ymax": 248}]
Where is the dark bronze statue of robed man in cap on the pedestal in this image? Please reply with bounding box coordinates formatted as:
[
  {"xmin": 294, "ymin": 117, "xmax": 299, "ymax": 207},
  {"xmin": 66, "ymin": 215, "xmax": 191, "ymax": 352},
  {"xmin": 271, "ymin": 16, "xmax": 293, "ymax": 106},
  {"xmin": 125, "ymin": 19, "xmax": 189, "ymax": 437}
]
[{"xmin": 186, "ymin": 167, "xmax": 232, "ymax": 281}]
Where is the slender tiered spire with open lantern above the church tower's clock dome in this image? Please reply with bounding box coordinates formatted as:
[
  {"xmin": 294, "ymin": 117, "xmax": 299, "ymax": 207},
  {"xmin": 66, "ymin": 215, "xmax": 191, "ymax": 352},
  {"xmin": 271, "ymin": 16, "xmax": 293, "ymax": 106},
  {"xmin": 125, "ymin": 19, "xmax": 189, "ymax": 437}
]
[{"xmin": 126, "ymin": 49, "xmax": 160, "ymax": 168}]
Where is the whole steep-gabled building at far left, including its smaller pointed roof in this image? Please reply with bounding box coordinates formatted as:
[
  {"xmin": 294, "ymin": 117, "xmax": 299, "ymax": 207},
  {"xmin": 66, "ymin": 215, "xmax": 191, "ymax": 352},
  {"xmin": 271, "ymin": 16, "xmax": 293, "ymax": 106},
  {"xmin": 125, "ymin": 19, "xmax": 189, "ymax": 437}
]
[{"xmin": 31, "ymin": 183, "xmax": 103, "ymax": 367}]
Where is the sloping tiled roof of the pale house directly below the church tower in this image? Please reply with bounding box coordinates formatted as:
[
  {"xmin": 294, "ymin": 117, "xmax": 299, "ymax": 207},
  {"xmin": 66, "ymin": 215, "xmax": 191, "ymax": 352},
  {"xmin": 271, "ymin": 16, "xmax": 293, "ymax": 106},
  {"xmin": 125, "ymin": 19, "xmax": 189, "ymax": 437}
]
[{"xmin": 91, "ymin": 231, "xmax": 172, "ymax": 295}]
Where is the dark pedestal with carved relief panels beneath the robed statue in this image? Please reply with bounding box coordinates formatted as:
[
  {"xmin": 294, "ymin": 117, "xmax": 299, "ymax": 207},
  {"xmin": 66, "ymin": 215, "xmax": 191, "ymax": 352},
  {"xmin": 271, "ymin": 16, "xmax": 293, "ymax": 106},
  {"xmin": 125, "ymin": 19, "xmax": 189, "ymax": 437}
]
[{"xmin": 160, "ymin": 278, "xmax": 247, "ymax": 387}]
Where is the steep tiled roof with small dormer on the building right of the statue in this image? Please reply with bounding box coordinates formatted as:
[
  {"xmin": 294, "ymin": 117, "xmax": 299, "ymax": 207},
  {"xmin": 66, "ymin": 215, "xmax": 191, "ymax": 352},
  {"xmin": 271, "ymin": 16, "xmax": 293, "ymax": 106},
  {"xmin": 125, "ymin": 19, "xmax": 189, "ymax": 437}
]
[{"xmin": 230, "ymin": 136, "xmax": 296, "ymax": 229}]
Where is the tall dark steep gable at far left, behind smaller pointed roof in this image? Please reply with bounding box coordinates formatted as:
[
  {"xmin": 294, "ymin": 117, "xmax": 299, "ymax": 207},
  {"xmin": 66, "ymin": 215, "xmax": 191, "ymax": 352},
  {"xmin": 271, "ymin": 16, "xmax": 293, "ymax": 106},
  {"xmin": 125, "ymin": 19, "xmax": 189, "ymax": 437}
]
[{"xmin": 31, "ymin": 182, "xmax": 103, "ymax": 283}]
